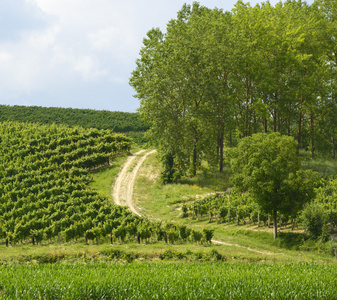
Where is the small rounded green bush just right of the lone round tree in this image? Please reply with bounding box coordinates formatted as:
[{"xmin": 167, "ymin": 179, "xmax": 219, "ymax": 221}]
[{"xmin": 302, "ymin": 203, "xmax": 327, "ymax": 238}]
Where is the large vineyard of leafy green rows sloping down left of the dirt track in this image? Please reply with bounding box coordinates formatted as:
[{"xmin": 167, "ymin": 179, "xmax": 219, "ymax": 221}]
[{"xmin": 0, "ymin": 122, "xmax": 141, "ymax": 245}]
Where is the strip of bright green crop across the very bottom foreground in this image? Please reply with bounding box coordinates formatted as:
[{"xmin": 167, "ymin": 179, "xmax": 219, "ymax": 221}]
[{"xmin": 0, "ymin": 262, "xmax": 337, "ymax": 299}]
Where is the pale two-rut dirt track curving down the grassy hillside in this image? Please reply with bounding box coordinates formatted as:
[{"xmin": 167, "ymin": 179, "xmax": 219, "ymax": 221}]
[{"xmin": 112, "ymin": 150, "xmax": 278, "ymax": 255}]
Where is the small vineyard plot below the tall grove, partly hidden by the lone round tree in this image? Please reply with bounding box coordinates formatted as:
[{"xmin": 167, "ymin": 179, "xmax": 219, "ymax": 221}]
[{"xmin": 182, "ymin": 189, "xmax": 337, "ymax": 230}]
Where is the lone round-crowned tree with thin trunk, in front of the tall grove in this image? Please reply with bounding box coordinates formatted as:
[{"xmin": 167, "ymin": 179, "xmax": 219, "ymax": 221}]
[{"xmin": 230, "ymin": 133, "xmax": 318, "ymax": 239}]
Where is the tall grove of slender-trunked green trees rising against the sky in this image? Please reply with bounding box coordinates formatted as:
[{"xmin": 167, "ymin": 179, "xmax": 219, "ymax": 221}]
[{"xmin": 130, "ymin": 0, "xmax": 337, "ymax": 174}]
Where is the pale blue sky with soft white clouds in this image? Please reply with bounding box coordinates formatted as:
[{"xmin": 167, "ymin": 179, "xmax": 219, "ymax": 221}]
[{"xmin": 0, "ymin": 0, "xmax": 313, "ymax": 112}]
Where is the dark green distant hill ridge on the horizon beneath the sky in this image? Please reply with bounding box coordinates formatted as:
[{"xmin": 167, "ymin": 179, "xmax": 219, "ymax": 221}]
[{"xmin": 0, "ymin": 105, "xmax": 148, "ymax": 133}]
